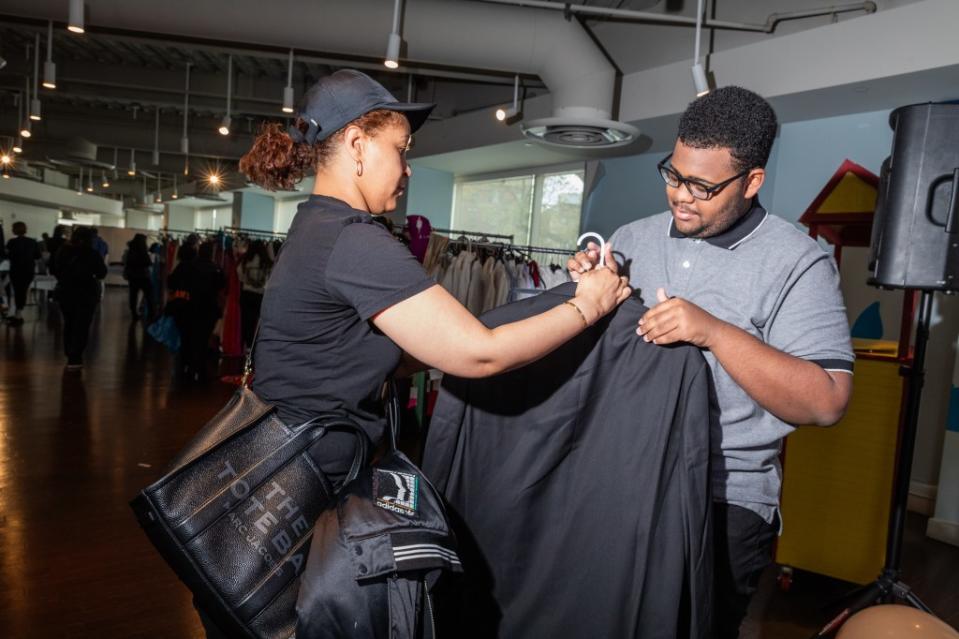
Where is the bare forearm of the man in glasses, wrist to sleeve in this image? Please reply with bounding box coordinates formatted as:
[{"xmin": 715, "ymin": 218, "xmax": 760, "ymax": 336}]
[{"xmin": 710, "ymin": 322, "xmax": 852, "ymax": 426}]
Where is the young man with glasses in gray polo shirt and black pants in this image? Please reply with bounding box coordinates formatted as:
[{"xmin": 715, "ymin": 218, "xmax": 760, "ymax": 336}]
[{"xmin": 569, "ymin": 87, "xmax": 854, "ymax": 639}]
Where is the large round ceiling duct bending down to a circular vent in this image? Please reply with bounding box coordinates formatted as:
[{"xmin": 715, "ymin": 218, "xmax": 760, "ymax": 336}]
[{"xmin": 7, "ymin": 0, "xmax": 638, "ymax": 148}]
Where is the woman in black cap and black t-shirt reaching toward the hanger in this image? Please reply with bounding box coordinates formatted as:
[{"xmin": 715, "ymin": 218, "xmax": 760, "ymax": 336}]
[{"xmin": 240, "ymin": 70, "xmax": 630, "ymax": 481}]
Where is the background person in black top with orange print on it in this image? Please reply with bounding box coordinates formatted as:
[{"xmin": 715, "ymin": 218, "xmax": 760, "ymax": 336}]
[{"xmin": 167, "ymin": 242, "xmax": 226, "ymax": 381}]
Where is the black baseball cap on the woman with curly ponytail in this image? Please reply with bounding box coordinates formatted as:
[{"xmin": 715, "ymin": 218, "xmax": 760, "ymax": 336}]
[{"xmin": 289, "ymin": 69, "xmax": 436, "ymax": 144}]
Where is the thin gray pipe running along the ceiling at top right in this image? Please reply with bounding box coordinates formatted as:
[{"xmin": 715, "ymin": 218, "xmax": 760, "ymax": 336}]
[{"xmin": 478, "ymin": 0, "xmax": 876, "ymax": 33}]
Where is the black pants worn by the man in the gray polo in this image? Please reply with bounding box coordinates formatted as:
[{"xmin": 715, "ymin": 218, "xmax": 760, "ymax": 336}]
[{"xmin": 713, "ymin": 502, "xmax": 779, "ymax": 639}]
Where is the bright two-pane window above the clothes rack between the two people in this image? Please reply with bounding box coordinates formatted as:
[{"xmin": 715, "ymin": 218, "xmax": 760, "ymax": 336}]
[{"xmin": 450, "ymin": 169, "xmax": 584, "ymax": 248}]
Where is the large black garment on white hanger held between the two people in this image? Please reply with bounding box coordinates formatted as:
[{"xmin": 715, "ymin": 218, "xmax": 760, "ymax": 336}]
[{"xmin": 423, "ymin": 283, "xmax": 712, "ymax": 639}]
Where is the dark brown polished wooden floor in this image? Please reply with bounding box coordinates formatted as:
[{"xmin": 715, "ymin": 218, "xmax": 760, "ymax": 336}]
[{"xmin": 0, "ymin": 289, "xmax": 959, "ymax": 639}]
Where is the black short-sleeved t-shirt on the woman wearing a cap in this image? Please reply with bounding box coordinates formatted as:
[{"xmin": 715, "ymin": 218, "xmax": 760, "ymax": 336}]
[{"xmin": 253, "ymin": 195, "xmax": 434, "ymax": 461}]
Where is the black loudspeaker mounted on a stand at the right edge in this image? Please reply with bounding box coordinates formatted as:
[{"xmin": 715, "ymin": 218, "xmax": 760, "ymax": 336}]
[{"xmin": 869, "ymin": 104, "xmax": 959, "ymax": 291}]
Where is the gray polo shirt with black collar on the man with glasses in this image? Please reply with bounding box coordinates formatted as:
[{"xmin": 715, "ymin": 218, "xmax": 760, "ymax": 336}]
[{"xmin": 609, "ymin": 202, "xmax": 854, "ymax": 522}]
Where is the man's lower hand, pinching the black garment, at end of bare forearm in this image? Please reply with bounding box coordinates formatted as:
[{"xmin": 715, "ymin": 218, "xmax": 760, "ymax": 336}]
[{"xmin": 636, "ymin": 288, "xmax": 726, "ymax": 348}]
